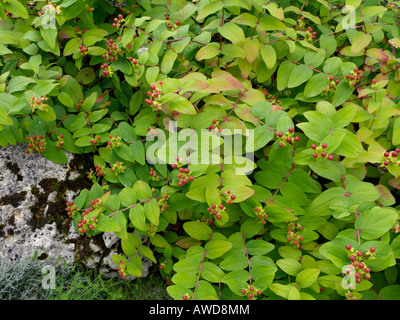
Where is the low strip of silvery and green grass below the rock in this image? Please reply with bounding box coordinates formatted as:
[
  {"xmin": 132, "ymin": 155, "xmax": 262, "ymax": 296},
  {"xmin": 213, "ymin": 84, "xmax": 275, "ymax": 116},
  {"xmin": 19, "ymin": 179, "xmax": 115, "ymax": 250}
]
[{"xmin": 0, "ymin": 259, "xmax": 171, "ymax": 300}]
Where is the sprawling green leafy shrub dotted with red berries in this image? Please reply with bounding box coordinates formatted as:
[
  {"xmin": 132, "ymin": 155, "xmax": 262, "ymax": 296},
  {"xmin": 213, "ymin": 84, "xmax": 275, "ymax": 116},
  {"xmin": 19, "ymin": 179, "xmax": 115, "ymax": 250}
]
[{"xmin": 0, "ymin": 0, "xmax": 400, "ymax": 300}]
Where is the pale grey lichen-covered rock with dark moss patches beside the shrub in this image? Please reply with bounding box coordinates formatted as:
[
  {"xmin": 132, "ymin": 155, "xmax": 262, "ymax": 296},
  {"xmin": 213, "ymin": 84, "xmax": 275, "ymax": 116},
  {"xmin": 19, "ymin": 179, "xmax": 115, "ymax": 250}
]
[{"xmin": 0, "ymin": 145, "xmax": 151, "ymax": 276}]
